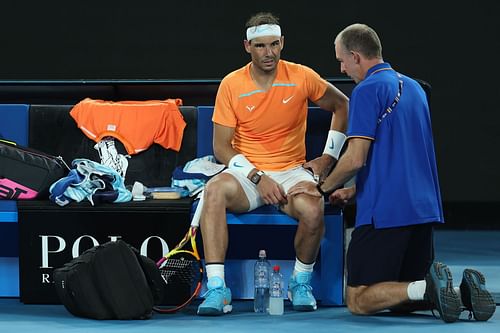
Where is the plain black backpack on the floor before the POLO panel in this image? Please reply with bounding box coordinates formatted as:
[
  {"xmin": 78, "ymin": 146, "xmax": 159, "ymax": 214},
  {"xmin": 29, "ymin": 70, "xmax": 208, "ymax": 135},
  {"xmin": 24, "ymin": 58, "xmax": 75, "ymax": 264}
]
[{"xmin": 53, "ymin": 240, "xmax": 165, "ymax": 320}]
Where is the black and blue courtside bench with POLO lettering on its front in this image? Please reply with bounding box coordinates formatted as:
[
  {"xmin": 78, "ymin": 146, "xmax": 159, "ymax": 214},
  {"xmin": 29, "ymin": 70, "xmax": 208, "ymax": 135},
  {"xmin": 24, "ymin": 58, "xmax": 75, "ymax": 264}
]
[{"xmin": 0, "ymin": 104, "xmax": 344, "ymax": 305}]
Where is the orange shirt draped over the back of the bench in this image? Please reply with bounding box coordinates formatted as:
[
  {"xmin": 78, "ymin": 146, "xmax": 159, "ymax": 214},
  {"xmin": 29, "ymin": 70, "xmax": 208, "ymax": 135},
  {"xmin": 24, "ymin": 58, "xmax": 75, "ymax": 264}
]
[{"xmin": 70, "ymin": 98, "xmax": 186, "ymax": 155}]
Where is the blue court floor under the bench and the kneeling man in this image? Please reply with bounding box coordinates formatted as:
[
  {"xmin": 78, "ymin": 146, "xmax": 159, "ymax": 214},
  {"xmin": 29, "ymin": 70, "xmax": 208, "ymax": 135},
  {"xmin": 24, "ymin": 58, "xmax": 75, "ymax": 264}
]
[{"xmin": 0, "ymin": 230, "xmax": 500, "ymax": 333}]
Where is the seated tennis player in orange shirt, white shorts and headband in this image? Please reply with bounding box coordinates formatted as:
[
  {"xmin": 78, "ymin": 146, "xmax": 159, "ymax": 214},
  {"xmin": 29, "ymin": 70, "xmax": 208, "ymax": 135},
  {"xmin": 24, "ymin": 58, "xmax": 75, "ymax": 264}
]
[{"xmin": 198, "ymin": 13, "xmax": 348, "ymax": 315}]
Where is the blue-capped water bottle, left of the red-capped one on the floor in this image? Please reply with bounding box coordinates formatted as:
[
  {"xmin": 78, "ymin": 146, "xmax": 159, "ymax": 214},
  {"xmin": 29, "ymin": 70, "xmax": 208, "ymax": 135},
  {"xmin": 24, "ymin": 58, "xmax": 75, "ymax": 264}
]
[{"xmin": 253, "ymin": 250, "xmax": 271, "ymax": 313}]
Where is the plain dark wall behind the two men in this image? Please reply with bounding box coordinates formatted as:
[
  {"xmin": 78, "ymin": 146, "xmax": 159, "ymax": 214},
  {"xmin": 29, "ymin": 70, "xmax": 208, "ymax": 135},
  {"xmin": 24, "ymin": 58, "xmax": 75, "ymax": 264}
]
[{"xmin": 0, "ymin": 0, "xmax": 500, "ymax": 202}]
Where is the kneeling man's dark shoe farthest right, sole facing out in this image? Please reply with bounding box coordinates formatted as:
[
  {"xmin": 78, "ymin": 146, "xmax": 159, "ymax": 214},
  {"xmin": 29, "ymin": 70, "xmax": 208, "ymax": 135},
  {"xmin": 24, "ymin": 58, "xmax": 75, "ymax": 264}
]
[{"xmin": 460, "ymin": 268, "xmax": 496, "ymax": 321}]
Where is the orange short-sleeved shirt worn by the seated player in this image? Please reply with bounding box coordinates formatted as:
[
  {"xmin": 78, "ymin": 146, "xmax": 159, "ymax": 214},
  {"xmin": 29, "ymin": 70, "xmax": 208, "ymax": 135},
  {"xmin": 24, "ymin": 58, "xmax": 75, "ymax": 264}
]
[{"xmin": 212, "ymin": 60, "xmax": 328, "ymax": 171}]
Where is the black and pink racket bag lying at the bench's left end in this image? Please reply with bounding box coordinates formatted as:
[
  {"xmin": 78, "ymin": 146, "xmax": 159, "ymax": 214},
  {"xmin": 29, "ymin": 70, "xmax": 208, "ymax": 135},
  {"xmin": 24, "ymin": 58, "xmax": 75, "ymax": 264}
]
[{"xmin": 0, "ymin": 140, "xmax": 69, "ymax": 200}]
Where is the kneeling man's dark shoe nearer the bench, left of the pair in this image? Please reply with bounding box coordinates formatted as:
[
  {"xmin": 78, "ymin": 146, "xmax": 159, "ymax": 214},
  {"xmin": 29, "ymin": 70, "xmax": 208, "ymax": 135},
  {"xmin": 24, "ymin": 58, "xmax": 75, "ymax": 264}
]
[{"xmin": 425, "ymin": 262, "xmax": 461, "ymax": 323}]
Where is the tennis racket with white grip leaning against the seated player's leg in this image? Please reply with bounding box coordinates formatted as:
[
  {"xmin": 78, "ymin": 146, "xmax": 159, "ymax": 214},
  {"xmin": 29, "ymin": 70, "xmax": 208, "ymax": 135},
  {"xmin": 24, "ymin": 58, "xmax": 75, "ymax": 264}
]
[{"xmin": 153, "ymin": 195, "xmax": 203, "ymax": 313}]
